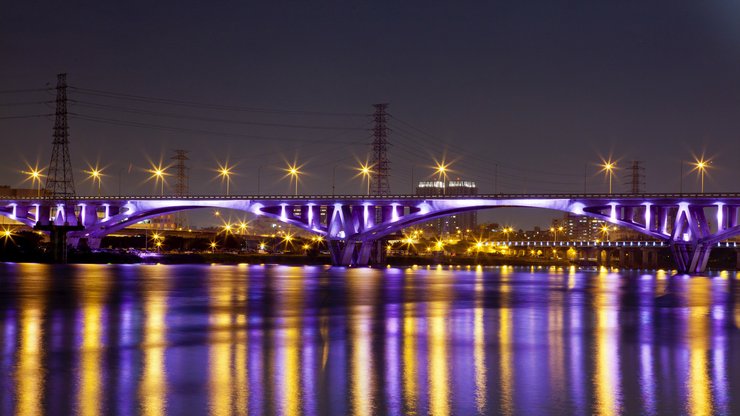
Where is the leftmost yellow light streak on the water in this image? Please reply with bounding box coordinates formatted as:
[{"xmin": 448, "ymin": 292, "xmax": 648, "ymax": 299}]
[{"xmin": 15, "ymin": 264, "xmax": 51, "ymax": 415}]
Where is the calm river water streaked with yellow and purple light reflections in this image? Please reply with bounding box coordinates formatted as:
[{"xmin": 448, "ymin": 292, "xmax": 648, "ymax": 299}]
[{"xmin": 0, "ymin": 264, "xmax": 740, "ymax": 415}]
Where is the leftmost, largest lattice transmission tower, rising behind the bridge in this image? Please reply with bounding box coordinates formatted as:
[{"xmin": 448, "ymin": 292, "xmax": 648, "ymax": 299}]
[{"xmin": 46, "ymin": 74, "xmax": 75, "ymax": 199}]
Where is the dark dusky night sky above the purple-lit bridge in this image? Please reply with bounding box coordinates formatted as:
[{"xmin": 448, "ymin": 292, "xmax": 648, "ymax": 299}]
[{"xmin": 0, "ymin": 0, "xmax": 740, "ymax": 228}]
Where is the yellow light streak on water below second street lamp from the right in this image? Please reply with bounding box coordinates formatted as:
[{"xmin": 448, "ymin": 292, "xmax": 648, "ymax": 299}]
[{"xmin": 594, "ymin": 270, "xmax": 622, "ymax": 415}]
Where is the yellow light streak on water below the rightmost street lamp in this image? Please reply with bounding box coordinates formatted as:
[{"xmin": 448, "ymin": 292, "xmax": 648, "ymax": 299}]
[{"xmin": 686, "ymin": 277, "xmax": 714, "ymax": 416}]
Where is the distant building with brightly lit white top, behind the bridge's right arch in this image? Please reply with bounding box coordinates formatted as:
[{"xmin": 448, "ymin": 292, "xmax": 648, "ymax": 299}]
[{"xmin": 416, "ymin": 179, "xmax": 478, "ymax": 236}]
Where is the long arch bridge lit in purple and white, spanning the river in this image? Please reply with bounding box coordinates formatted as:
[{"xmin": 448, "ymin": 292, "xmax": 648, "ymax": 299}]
[{"xmin": 0, "ymin": 193, "xmax": 740, "ymax": 272}]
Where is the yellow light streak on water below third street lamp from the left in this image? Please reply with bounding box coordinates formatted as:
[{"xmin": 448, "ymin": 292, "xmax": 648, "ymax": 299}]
[{"xmin": 139, "ymin": 266, "xmax": 168, "ymax": 416}]
